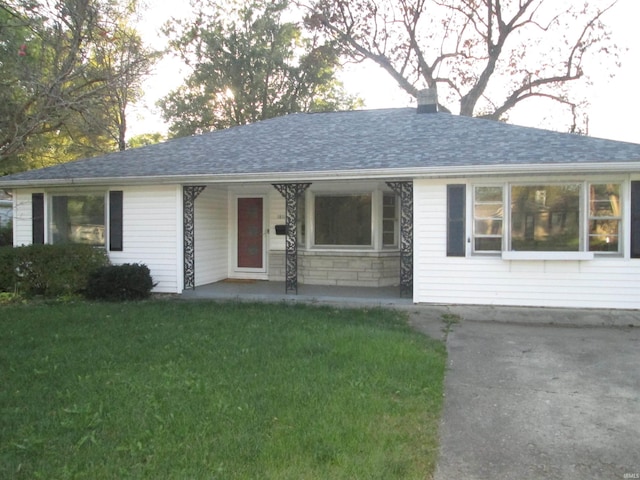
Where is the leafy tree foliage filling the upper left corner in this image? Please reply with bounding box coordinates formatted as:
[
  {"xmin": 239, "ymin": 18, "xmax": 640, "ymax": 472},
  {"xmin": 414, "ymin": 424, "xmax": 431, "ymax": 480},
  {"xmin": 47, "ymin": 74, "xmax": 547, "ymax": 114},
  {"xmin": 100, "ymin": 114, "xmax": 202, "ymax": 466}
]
[{"xmin": 0, "ymin": 0, "xmax": 155, "ymax": 171}]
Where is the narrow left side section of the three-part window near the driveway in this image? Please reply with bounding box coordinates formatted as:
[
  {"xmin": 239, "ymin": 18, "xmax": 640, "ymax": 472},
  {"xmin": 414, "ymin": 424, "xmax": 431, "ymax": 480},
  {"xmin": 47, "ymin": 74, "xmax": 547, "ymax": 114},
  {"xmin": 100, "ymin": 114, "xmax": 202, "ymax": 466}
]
[{"xmin": 473, "ymin": 186, "xmax": 504, "ymax": 253}]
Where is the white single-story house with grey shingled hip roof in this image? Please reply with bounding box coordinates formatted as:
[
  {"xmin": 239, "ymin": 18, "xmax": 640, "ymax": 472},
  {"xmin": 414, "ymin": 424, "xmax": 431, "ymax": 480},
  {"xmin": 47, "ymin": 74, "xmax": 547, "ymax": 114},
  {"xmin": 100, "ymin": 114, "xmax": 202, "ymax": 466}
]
[{"xmin": 0, "ymin": 89, "xmax": 640, "ymax": 309}]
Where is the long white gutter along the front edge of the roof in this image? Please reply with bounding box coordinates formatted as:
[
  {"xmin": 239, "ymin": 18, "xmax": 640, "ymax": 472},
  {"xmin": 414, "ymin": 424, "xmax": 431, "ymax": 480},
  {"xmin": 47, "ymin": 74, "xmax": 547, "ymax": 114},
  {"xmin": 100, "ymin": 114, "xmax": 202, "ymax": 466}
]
[{"xmin": 0, "ymin": 161, "xmax": 640, "ymax": 189}]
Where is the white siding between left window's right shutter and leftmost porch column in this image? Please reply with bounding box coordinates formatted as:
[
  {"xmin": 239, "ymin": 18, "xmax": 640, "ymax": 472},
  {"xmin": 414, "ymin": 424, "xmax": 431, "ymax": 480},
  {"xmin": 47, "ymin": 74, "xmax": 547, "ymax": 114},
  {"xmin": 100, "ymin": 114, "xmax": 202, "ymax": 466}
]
[{"xmin": 109, "ymin": 185, "xmax": 183, "ymax": 293}]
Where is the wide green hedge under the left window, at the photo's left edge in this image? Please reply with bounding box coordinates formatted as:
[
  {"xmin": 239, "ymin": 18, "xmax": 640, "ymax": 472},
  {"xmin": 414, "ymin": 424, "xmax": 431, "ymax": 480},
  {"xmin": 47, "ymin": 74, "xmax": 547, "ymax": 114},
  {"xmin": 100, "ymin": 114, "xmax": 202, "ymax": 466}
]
[{"xmin": 0, "ymin": 245, "xmax": 109, "ymax": 297}]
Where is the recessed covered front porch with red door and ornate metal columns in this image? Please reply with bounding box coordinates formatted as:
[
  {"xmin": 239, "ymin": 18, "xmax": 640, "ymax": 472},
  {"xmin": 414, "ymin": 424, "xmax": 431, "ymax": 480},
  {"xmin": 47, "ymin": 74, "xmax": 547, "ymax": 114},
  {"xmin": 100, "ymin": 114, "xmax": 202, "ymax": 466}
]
[{"xmin": 183, "ymin": 180, "xmax": 413, "ymax": 298}]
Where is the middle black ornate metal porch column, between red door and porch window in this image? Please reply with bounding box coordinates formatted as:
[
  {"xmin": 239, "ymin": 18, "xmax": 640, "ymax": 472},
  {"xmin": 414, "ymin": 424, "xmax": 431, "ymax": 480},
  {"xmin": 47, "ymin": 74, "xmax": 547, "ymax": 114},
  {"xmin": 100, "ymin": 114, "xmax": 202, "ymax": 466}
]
[{"xmin": 273, "ymin": 183, "xmax": 311, "ymax": 294}]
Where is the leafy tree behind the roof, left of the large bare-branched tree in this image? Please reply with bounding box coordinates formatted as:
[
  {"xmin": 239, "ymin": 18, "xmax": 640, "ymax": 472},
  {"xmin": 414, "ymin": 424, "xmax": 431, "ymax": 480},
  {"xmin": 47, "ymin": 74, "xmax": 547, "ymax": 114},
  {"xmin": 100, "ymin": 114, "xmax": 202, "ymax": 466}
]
[{"xmin": 159, "ymin": 0, "xmax": 361, "ymax": 136}]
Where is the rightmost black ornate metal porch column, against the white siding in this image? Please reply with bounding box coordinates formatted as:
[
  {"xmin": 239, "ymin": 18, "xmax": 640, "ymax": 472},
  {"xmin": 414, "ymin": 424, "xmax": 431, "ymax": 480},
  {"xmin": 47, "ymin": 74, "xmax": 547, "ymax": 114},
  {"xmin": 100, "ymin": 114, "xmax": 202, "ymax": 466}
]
[{"xmin": 387, "ymin": 182, "xmax": 413, "ymax": 297}]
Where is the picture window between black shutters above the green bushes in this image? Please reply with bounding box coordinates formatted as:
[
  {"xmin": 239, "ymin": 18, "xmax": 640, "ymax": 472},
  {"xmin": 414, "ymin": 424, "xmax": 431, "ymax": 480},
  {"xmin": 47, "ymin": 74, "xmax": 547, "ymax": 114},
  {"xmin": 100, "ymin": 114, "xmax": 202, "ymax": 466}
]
[{"xmin": 49, "ymin": 194, "xmax": 105, "ymax": 246}]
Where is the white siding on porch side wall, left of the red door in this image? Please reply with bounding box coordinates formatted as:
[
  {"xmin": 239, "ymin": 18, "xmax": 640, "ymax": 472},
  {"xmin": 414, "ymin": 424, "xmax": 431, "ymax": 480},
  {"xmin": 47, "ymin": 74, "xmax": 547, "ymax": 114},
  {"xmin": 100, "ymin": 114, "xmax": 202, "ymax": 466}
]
[{"xmin": 194, "ymin": 185, "xmax": 229, "ymax": 286}]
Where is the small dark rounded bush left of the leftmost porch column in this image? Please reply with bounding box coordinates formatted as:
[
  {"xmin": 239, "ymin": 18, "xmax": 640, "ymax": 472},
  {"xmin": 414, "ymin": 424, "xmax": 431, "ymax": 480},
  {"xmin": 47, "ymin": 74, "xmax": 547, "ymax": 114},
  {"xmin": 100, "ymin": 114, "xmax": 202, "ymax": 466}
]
[{"xmin": 84, "ymin": 263, "xmax": 154, "ymax": 302}]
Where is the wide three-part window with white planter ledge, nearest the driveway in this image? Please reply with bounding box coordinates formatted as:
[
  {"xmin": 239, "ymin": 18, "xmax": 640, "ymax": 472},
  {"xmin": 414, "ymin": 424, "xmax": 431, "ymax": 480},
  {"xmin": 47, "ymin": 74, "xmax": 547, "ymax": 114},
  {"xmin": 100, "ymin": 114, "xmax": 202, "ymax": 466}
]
[{"xmin": 473, "ymin": 182, "xmax": 622, "ymax": 253}]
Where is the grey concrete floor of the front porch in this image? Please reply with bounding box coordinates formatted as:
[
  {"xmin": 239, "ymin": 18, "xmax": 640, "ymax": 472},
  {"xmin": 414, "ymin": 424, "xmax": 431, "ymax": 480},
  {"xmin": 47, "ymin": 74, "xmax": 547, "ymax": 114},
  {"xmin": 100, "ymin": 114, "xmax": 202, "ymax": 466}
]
[{"xmin": 182, "ymin": 279, "xmax": 413, "ymax": 307}]
